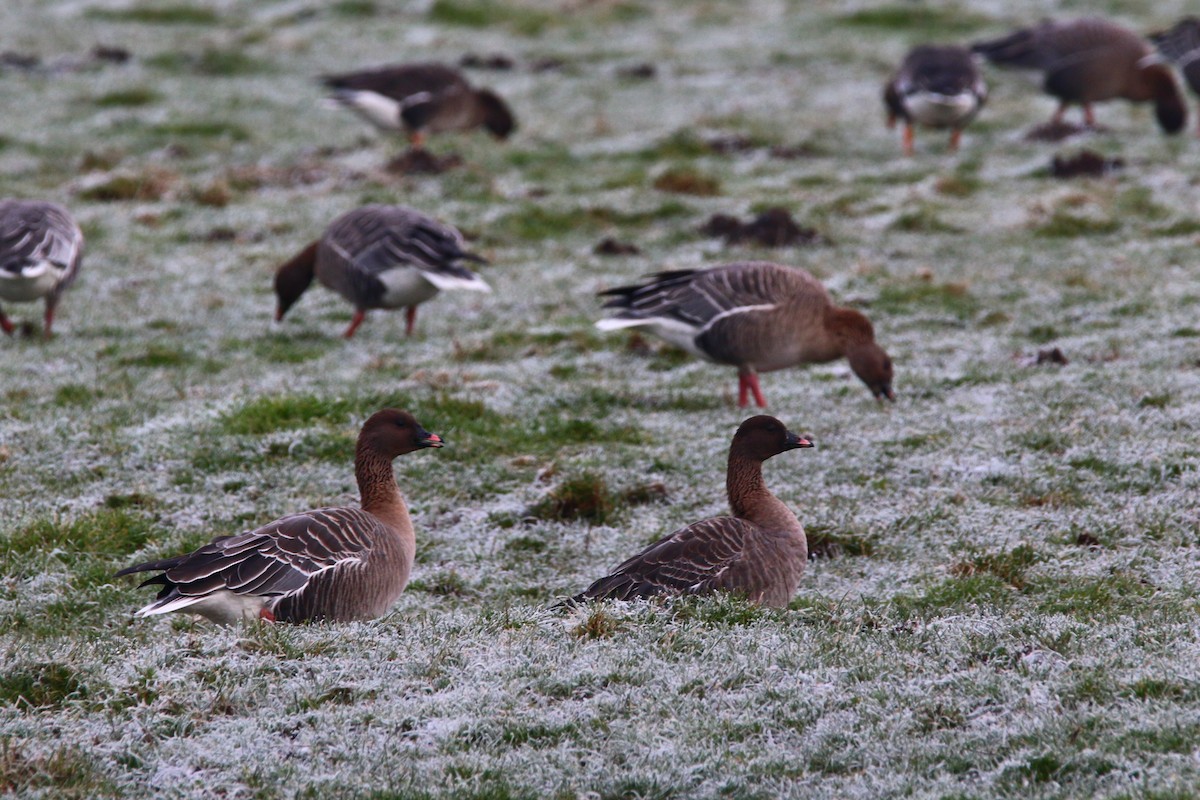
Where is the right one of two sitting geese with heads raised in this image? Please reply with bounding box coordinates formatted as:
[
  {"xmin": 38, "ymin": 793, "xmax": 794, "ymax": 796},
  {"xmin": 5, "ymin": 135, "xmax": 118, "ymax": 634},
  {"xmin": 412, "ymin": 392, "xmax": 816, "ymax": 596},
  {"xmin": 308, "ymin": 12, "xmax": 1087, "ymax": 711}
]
[{"xmin": 571, "ymin": 415, "xmax": 812, "ymax": 608}]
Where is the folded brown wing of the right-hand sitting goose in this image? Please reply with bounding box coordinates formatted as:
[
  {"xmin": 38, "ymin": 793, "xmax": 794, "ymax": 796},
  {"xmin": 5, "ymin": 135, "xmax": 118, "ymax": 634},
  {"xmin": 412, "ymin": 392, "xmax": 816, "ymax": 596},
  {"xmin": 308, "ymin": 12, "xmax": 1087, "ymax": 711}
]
[{"xmin": 572, "ymin": 517, "xmax": 761, "ymax": 602}]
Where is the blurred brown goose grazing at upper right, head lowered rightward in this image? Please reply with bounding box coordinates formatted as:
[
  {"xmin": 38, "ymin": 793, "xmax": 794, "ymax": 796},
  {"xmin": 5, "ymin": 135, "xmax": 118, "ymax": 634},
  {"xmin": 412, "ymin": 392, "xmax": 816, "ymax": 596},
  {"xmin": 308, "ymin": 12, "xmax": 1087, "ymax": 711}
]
[{"xmin": 971, "ymin": 17, "xmax": 1187, "ymax": 133}]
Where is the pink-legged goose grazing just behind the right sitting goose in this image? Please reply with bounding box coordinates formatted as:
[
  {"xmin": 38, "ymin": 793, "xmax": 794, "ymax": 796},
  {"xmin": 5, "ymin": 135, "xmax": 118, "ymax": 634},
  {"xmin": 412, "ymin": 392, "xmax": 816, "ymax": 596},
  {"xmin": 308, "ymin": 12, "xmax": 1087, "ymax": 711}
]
[{"xmin": 596, "ymin": 261, "xmax": 895, "ymax": 408}]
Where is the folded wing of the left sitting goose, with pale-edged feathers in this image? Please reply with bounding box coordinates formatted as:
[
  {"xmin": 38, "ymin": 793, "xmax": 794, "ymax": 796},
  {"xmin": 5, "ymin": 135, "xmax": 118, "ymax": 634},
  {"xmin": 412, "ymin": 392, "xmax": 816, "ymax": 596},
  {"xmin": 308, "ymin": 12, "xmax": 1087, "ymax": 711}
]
[{"xmin": 116, "ymin": 509, "xmax": 383, "ymax": 616}]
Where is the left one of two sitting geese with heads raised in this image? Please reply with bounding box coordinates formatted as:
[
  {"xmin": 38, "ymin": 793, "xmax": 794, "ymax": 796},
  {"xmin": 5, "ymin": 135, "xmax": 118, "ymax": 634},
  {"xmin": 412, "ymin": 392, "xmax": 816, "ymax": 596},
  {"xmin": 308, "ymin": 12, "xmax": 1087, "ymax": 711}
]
[{"xmin": 116, "ymin": 408, "xmax": 443, "ymax": 625}]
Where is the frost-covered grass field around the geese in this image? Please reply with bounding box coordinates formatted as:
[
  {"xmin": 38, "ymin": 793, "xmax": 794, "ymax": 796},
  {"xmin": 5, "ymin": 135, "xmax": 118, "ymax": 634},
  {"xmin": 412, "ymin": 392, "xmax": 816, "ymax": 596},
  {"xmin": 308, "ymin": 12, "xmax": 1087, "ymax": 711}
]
[{"xmin": 0, "ymin": 0, "xmax": 1200, "ymax": 798}]
